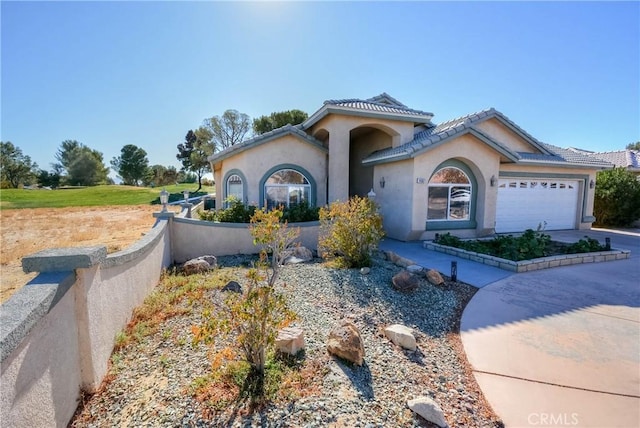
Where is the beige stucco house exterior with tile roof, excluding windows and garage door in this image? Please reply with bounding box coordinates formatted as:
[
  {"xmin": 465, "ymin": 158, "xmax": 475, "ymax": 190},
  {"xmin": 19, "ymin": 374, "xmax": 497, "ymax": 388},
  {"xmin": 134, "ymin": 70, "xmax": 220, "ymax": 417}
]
[{"xmin": 212, "ymin": 97, "xmax": 602, "ymax": 240}]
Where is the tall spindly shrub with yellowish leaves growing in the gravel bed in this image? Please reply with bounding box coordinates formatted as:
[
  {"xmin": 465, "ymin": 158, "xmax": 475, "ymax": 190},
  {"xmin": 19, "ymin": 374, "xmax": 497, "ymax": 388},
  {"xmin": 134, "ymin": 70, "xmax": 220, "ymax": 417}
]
[{"xmin": 194, "ymin": 209, "xmax": 300, "ymax": 396}]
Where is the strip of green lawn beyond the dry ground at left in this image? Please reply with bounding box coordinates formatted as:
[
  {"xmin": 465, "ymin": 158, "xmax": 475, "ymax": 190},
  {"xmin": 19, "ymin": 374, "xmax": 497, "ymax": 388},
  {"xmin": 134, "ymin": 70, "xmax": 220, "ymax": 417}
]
[{"xmin": 0, "ymin": 184, "xmax": 214, "ymax": 209}]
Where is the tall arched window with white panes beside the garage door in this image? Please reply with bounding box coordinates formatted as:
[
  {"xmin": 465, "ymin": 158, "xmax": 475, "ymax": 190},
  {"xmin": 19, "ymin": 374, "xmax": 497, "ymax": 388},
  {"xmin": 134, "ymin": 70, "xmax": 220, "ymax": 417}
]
[{"xmin": 427, "ymin": 167, "xmax": 471, "ymax": 221}]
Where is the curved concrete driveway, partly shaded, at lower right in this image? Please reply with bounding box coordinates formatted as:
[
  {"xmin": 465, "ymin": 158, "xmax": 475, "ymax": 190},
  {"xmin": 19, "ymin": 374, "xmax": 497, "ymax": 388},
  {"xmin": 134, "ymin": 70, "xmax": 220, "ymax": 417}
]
[{"xmin": 461, "ymin": 230, "xmax": 640, "ymax": 427}]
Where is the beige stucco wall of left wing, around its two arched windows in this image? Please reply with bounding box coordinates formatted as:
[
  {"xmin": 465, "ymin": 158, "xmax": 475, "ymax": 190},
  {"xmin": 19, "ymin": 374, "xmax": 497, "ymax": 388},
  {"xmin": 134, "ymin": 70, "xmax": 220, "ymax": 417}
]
[{"xmin": 215, "ymin": 135, "xmax": 327, "ymax": 207}]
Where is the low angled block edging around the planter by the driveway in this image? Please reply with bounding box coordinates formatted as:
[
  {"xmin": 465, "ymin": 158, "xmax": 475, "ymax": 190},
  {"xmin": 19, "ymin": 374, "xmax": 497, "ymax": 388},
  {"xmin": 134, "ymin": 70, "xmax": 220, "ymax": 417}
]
[{"xmin": 423, "ymin": 241, "xmax": 631, "ymax": 273}]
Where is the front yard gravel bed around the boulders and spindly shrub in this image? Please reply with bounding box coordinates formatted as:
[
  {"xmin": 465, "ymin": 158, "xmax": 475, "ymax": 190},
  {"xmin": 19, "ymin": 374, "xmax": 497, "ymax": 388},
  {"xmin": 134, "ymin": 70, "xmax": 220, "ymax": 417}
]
[{"xmin": 70, "ymin": 257, "xmax": 502, "ymax": 428}]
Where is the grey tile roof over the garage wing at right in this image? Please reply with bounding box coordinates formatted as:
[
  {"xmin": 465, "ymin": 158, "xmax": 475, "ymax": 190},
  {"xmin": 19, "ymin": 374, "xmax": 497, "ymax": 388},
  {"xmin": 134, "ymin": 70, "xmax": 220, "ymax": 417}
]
[{"xmin": 363, "ymin": 108, "xmax": 610, "ymax": 167}]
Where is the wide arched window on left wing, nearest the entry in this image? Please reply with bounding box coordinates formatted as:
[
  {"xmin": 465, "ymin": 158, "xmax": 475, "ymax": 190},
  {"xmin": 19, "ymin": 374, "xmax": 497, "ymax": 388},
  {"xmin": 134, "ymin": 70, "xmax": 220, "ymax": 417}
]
[{"xmin": 264, "ymin": 169, "xmax": 311, "ymax": 209}]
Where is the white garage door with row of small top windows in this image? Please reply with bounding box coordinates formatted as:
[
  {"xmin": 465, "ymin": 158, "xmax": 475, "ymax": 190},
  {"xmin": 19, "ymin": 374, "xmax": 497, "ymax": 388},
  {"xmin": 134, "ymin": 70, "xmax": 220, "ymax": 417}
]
[{"xmin": 496, "ymin": 179, "xmax": 579, "ymax": 233}]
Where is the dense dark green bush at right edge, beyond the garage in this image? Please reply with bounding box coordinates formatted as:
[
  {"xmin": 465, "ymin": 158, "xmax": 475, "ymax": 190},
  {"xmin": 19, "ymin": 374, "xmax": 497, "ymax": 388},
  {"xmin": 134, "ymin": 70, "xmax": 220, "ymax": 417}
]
[{"xmin": 593, "ymin": 167, "xmax": 640, "ymax": 226}]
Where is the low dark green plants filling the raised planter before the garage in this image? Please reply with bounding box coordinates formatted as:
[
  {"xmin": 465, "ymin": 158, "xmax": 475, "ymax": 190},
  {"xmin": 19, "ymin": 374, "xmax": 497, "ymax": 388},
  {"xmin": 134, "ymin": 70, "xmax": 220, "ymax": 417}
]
[{"xmin": 434, "ymin": 229, "xmax": 607, "ymax": 262}]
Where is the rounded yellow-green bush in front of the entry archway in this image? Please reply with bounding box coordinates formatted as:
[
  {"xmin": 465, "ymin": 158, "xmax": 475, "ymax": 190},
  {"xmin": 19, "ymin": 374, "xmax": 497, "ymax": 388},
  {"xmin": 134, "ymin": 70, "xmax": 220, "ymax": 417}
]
[{"xmin": 318, "ymin": 196, "xmax": 384, "ymax": 268}]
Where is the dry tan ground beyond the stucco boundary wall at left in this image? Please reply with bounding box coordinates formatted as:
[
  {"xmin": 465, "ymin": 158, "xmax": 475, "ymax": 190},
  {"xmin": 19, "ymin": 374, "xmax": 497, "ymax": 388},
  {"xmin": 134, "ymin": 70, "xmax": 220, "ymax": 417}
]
[{"xmin": 0, "ymin": 205, "xmax": 179, "ymax": 304}]
